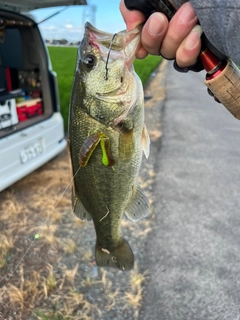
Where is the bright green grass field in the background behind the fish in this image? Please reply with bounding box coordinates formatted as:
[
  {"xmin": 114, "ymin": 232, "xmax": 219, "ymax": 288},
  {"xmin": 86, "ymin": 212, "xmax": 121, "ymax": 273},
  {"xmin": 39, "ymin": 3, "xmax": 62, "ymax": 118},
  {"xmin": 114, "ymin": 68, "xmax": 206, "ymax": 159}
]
[{"xmin": 48, "ymin": 47, "xmax": 161, "ymax": 130}]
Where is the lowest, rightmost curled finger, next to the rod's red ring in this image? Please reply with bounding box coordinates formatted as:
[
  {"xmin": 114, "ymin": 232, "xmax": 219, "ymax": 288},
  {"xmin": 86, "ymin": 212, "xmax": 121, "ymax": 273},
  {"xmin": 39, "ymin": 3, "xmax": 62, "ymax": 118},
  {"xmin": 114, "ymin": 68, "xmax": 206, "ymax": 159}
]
[{"xmin": 176, "ymin": 25, "xmax": 203, "ymax": 68}]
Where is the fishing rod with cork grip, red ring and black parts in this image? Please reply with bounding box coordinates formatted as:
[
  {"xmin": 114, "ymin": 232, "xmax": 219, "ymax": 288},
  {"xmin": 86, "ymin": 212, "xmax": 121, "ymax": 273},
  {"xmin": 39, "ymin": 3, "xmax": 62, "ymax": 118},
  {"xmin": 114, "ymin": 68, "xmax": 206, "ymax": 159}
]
[{"xmin": 124, "ymin": 0, "xmax": 240, "ymax": 120}]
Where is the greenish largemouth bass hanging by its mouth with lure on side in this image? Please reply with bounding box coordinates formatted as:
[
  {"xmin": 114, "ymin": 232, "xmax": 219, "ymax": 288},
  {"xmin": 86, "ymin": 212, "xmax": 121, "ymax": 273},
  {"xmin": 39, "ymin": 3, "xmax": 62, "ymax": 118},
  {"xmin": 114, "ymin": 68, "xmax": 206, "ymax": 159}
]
[{"xmin": 68, "ymin": 22, "xmax": 150, "ymax": 271}]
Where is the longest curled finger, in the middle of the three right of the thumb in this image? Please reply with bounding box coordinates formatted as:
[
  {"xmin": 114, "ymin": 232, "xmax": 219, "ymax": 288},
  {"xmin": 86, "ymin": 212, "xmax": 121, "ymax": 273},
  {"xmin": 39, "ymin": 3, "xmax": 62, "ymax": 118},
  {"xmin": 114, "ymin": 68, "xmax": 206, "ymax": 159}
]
[{"xmin": 160, "ymin": 2, "xmax": 198, "ymax": 59}]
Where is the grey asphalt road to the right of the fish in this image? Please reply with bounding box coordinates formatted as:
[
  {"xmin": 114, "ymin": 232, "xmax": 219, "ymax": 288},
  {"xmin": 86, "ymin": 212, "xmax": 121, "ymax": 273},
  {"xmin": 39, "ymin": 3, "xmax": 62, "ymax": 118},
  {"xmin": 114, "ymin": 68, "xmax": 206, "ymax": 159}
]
[{"xmin": 140, "ymin": 63, "xmax": 240, "ymax": 320}]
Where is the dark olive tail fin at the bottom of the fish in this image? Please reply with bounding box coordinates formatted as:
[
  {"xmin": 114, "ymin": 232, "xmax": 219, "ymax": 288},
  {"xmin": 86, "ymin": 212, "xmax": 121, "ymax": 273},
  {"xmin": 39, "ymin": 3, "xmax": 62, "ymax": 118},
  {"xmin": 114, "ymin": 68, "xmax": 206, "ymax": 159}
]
[{"xmin": 95, "ymin": 238, "xmax": 134, "ymax": 271}]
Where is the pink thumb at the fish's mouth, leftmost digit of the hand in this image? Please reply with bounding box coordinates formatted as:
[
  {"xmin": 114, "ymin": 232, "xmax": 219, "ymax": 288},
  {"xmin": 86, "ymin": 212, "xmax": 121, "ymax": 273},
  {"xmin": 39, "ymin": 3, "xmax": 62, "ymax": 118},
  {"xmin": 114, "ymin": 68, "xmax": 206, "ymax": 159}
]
[{"xmin": 120, "ymin": 0, "xmax": 146, "ymax": 31}]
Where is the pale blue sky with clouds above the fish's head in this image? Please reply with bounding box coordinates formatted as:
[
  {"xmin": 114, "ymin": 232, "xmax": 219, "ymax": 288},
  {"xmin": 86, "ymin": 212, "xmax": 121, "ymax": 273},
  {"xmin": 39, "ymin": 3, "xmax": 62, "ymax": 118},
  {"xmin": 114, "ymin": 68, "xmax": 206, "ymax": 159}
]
[{"xmin": 31, "ymin": 0, "xmax": 125, "ymax": 42}]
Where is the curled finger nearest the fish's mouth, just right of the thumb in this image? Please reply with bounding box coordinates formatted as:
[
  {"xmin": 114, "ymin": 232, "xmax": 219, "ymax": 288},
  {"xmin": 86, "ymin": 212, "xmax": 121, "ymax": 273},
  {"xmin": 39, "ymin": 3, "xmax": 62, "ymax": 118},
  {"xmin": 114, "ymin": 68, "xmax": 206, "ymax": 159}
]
[{"xmin": 142, "ymin": 12, "xmax": 168, "ymax": 55}]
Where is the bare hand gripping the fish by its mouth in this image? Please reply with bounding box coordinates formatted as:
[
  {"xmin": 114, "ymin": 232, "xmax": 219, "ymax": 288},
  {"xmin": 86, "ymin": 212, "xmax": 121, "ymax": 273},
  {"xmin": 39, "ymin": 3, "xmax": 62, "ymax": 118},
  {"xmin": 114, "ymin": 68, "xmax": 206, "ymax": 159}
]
[{"xmin": 120, "ymin": 0, "xmax": 202, "ymax": 68}]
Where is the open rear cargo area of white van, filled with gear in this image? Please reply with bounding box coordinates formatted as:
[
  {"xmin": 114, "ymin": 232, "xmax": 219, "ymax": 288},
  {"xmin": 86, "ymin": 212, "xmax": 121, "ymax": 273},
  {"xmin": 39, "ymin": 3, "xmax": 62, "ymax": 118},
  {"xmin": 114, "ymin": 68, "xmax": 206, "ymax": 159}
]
[{"xmin": 0, "ymin": 10, "xmax": 58, "ymax": 138}]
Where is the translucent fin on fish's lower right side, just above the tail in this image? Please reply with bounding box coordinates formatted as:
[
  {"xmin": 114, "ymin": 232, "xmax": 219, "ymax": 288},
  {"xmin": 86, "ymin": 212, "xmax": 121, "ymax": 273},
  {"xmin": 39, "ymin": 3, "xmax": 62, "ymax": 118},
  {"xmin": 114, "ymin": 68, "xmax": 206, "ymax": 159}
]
[{"xmin": 124, "ymin": 185, "xmax": 150, "ymax": 221}]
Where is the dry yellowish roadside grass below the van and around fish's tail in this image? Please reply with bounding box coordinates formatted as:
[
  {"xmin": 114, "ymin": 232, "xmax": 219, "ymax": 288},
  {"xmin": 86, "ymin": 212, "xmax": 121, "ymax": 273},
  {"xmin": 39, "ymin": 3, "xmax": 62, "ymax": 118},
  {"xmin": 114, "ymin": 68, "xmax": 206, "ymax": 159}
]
[{"xmin": 0, "ymin": 152, "xmax": 148, "ymax": 320}]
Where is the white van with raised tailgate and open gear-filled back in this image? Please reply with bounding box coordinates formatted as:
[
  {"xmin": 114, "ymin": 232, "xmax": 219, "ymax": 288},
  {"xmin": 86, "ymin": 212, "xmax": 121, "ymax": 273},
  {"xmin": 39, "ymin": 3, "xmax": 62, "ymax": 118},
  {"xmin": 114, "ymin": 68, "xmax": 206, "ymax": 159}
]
[{"xmin": 0, "ymin": 0, "xmax": 86, "ymax": 191}]
